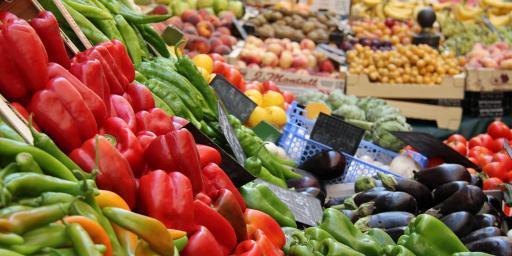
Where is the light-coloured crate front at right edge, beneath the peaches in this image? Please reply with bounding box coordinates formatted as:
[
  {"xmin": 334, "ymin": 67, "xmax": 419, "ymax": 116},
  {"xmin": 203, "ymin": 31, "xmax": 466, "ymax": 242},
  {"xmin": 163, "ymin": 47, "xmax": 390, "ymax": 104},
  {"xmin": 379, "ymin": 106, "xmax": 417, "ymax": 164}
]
[{"xmin": 466, "ymin": 68, "xmax": 512, "ymax": 92}]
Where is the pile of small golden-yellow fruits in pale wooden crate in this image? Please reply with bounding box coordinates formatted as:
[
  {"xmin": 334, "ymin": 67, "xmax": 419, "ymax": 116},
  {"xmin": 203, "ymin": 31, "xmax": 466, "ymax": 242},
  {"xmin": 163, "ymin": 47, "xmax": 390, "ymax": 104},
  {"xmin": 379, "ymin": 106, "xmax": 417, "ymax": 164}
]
[{"xmin": 347, "ymin": 45, "xmax": 464, "ymax": 84}]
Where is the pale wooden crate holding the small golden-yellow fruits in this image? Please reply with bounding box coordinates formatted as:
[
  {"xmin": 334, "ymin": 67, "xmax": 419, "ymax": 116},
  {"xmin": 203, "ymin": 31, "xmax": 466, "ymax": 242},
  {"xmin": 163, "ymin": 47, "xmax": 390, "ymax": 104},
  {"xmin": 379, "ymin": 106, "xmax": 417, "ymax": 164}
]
[{"xmin": 346, "ymin": 72, "xmax": 465, "ymax": 99}]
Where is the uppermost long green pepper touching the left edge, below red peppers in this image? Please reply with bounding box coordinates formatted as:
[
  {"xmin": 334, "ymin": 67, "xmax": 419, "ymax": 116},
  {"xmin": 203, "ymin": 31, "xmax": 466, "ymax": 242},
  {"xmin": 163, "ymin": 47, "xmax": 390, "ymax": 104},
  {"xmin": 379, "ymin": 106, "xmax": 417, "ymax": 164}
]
[{"xmin": 0, "ymin": 138, "xmax": 77, "ymax": 181}]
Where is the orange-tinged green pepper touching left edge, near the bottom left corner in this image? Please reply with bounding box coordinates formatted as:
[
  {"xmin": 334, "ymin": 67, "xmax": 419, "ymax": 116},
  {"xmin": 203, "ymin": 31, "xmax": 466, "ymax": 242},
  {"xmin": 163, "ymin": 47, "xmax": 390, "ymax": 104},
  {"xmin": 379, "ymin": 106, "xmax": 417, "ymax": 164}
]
[{"xmin": 0, "ymin": 203, "xmax": 70, "ymax": 234}]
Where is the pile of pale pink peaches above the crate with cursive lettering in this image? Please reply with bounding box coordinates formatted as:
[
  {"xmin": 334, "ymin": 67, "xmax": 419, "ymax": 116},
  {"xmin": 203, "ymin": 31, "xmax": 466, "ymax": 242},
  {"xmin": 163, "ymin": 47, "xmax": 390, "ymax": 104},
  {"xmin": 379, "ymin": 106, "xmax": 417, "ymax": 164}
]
[{"xmin": 236, "ymin": 36, "xmax": 339, "ymax": 77}]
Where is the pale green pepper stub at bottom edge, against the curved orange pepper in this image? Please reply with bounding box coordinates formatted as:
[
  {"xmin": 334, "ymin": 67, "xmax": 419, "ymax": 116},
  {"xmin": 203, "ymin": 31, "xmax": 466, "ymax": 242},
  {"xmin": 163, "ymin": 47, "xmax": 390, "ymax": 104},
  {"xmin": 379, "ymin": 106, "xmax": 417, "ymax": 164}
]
[{"xmin": 66, "ymin": 223, "xmax": 101, "ymax": 256}]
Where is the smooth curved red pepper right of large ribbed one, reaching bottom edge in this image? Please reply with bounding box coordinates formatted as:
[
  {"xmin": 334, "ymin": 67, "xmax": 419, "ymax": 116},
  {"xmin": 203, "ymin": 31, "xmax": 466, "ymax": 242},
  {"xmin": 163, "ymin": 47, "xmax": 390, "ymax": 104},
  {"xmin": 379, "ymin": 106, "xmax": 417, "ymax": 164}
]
[{"xmin": 194, "ymin": 200, "xmax": 237, "ymax": 255}]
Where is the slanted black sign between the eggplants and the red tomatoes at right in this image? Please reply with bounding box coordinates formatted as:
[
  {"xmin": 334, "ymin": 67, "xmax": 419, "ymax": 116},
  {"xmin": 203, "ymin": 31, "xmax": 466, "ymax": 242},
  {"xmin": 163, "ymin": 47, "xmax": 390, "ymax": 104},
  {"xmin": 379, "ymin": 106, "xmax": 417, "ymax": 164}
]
[{"xmin": 392, "ymin": 132, "xmax": 480, "ymax": 170}]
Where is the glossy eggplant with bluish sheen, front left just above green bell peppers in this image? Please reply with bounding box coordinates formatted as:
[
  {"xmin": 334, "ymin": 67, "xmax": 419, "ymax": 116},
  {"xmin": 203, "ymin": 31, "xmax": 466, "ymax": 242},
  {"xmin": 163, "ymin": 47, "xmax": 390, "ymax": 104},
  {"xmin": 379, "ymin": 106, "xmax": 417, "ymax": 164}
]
[{"xmin": 355, "ymin": 211, "xmax": 415, "ymax": 230}]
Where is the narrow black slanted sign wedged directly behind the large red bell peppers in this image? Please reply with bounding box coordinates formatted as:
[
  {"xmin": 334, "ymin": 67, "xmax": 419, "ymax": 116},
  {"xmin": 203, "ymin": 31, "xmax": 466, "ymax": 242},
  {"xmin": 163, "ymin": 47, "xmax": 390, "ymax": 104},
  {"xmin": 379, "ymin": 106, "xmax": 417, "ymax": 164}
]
[{"xmin": 184, "ymin": 123, "xmax": 255, "ymax": 187}]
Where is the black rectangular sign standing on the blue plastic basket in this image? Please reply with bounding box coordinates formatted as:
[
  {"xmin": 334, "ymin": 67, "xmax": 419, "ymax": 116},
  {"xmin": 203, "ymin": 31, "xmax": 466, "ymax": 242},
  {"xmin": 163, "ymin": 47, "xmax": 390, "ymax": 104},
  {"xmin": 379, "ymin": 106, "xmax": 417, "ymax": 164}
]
[{"xmin": 310, "ymin": 113, "xmax": 364, "ymax": 155}]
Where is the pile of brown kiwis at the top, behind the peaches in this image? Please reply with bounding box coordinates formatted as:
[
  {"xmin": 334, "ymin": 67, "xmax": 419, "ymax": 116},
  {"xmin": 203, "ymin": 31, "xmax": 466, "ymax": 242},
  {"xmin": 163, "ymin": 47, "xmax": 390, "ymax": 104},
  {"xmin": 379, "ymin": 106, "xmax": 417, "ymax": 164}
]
[{"xmin": 247, "ymin": 8, "xmax": 338, "ymax": 42}]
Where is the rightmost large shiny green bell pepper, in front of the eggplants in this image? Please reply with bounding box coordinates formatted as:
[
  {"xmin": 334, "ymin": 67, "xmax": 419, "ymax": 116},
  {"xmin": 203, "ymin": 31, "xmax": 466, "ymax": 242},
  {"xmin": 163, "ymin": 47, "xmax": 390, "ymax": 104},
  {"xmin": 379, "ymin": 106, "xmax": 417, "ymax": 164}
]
[{"xmin": 398, "ymin": 214, "xmax": 468, "ymax": 256}]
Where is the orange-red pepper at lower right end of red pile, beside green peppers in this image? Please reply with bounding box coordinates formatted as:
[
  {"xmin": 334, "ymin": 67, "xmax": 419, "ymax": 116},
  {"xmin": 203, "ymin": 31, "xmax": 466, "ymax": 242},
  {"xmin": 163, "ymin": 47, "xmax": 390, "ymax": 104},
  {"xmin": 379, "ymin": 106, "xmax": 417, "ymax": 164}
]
[{"xmin": 244, "ymin": 208, "xmax": 286, "ymax": 248}]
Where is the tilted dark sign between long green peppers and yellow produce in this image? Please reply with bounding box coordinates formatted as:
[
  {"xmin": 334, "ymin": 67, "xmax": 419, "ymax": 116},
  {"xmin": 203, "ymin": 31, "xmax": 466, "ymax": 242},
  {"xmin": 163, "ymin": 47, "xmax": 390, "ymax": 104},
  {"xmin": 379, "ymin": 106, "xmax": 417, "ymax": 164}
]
[{"xmin": 210, "ymin": 75, "xmax": 256, "ymax": 123}]
